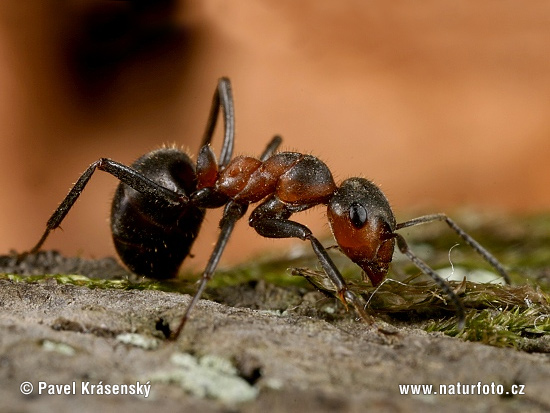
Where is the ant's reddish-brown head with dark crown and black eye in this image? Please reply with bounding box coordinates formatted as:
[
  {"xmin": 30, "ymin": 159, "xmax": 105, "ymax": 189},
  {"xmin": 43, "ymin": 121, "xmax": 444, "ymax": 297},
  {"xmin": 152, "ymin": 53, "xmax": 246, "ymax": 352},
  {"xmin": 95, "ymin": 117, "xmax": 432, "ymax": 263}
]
[{"xmin": 327, "ymin": 178, "xmax": 396, "ymax": 286}]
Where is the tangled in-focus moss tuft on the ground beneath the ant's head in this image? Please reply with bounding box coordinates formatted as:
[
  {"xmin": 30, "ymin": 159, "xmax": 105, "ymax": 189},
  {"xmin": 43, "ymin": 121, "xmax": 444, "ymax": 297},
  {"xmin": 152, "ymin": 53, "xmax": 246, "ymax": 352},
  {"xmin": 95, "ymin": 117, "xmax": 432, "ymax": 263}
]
[{"xmin": 294, "ymin": 268, "xmax": 550, "ymax": 348}]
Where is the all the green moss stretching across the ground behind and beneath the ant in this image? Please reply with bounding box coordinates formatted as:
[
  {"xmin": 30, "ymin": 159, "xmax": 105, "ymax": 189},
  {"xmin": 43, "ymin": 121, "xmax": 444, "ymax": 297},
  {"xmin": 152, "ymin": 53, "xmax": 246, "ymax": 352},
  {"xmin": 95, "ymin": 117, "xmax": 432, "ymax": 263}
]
[{"xmin": 4, "ymin": 214, "xmax": 550, "ymax": 348}]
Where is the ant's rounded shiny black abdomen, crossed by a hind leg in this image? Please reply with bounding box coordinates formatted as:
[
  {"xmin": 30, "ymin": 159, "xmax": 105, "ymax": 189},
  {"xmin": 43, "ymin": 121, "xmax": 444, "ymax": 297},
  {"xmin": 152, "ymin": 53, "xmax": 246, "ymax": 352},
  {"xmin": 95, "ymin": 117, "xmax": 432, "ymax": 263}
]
[{"xmin": 111, "ymin": 148, "xmax": 204, "ymax": 279}]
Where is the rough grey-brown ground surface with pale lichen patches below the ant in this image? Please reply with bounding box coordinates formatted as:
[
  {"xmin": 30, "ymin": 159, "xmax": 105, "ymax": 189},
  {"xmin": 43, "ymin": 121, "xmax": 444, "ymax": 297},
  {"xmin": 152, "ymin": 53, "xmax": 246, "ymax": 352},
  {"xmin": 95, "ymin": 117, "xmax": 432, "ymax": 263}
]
[{"xmin": 0, "ymin": 214, "xmax": 550, "ymax": 412}]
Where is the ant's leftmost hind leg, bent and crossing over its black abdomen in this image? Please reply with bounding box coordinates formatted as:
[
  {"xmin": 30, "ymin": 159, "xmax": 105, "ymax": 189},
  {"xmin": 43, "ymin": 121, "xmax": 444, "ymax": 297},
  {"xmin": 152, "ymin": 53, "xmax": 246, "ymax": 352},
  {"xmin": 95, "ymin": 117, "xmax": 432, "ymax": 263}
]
[{"xmin": 25, "ymin": 158, "xmax": 189, "ymax": 257}]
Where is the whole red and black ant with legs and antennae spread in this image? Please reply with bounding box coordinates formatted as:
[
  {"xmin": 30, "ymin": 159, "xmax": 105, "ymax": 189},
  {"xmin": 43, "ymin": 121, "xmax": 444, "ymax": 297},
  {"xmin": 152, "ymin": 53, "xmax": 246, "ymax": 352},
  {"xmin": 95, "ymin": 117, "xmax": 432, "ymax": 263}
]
[{"xmin": 22, "ymin": 78, "xmax": 510, "ymax": 339}]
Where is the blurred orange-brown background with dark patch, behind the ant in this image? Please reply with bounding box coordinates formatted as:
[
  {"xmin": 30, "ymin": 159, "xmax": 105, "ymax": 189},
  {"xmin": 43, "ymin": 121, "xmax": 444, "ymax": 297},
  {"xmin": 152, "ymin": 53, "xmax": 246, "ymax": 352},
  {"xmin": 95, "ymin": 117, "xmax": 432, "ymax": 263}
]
[{"xmin": 0, "ymin": 0, "xmax": 550, "ymax": 267}]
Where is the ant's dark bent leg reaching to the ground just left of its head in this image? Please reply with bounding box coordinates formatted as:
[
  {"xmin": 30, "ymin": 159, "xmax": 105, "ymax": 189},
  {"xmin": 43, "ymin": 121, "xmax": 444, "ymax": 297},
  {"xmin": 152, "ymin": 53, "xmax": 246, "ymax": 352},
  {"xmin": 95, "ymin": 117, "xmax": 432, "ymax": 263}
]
[{"xmin": 249, "ymin": 196, "xmax": 372, "ymax": 323}]
